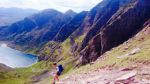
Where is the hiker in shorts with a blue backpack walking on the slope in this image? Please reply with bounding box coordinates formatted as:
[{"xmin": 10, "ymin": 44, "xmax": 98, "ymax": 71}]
[{"xmin": 52, "ymin": 63, "xmax": 64, "ymax": 84}]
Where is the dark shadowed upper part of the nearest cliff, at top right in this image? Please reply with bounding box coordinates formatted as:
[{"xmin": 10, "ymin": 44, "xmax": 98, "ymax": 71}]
[{"xmin": 101, "ymin": 0, "xmax": 150, "ymax": 53}]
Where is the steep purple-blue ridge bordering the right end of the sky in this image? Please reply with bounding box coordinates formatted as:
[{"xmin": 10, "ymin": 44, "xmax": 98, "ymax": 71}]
[{"xmin": 73, "ymin": 0, "xmax": 111, "ymax": 36}]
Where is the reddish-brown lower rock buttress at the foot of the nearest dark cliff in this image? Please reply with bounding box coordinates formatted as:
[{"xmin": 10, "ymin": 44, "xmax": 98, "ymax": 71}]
[{"xmin": 79, "ymin": 35, "xmax": 102, "ymax": 65}]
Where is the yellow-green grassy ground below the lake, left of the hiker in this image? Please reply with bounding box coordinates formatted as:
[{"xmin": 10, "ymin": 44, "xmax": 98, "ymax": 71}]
[{"xmin": 0, "ymin": 61, "xmax": 52, "ymax": 84}]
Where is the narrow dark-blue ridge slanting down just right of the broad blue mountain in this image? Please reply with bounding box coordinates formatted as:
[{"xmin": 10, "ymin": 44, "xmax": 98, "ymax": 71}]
[{"xmin": 54, "ymin": 11, "xmax": 87, "ymax": 42}]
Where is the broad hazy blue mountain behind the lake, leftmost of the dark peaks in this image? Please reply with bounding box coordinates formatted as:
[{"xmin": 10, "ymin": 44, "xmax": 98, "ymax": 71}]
[{"xmin": 0, "ymin": 9, "xmax": 75, "ymax": 48}]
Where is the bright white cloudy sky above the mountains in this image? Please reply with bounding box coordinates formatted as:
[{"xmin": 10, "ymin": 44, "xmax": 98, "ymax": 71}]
[{"xmin": 0, "ymin": 0, "xmax": 101, "ymax": 12}]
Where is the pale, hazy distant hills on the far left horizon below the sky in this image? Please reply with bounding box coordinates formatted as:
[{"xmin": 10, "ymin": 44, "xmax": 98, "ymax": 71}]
[{"xmin": 0, "ymin": 8, "xmax": 38, "ymax": 26}]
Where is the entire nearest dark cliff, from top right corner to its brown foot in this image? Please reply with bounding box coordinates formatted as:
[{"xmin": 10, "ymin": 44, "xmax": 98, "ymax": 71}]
[{"xmin": 80, "ymin": 0, "xmax": 150, "ymax": 64}]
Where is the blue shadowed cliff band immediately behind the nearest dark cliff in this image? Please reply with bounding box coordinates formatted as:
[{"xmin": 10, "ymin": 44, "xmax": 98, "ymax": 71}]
[{"xmin": 80, "ymin": 0, "xmax": 121, "ymax": 50}]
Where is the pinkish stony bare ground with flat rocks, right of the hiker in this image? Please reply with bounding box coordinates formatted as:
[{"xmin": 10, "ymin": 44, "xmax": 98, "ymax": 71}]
[{"xmin": 57, "ymin": 65, "xmax": 150, "ymax": 84}]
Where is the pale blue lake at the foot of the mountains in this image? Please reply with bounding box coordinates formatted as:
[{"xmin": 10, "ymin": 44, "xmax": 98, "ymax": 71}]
[{"xmin": 0, "ymin": 44, "xmax": 38, "ymax": 68}]
